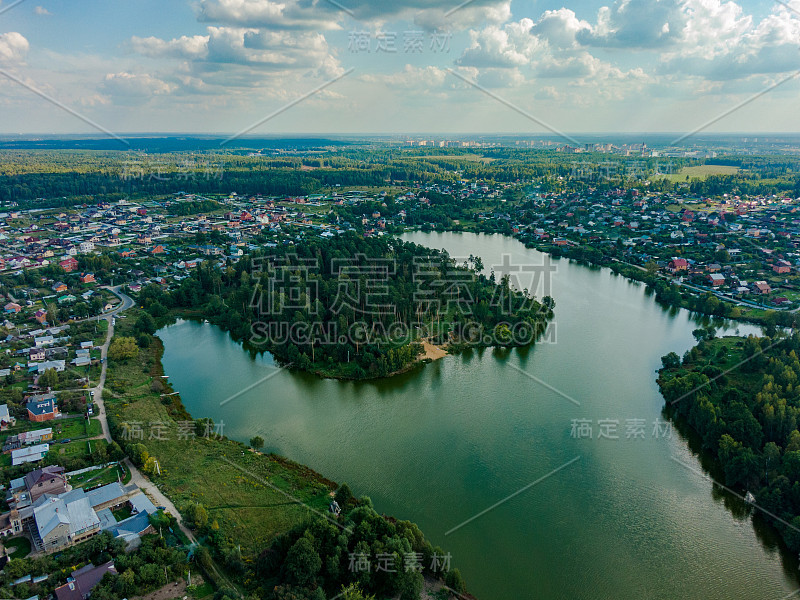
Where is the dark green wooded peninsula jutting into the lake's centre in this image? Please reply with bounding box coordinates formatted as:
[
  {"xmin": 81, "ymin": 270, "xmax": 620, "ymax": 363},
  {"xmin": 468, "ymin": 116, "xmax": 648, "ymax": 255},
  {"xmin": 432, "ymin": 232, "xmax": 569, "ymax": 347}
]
[{"xmin": 134, "ymin": 233, "xmax": 554, "ymax": 379}]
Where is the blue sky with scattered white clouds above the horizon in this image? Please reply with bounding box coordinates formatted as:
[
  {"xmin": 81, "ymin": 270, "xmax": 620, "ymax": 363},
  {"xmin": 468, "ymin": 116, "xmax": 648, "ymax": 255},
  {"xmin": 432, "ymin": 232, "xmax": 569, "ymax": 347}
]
[{"xmin": 0, "ymin": 0, "xmax": 800, "ymax": 137}]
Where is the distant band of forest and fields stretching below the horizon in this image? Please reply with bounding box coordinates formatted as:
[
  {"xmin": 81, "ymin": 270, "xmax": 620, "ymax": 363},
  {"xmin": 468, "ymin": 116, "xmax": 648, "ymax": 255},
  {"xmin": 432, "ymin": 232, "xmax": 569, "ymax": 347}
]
[{"xmin": 0, "ymin": 142, "xmax": 800, "ymax": 205}]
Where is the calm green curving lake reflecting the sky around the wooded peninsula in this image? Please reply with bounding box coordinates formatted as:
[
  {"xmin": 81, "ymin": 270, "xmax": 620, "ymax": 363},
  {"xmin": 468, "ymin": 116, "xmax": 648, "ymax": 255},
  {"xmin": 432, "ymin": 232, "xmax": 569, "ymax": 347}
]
[{"xmin": 158, "ymin": 233, "xmax": 800, "ymax": 600}]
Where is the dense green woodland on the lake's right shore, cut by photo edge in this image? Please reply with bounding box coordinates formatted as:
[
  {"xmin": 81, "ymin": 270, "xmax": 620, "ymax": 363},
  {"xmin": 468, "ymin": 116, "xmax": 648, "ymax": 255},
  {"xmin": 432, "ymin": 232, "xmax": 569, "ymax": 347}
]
[{"xmin": 658, "ymin": 330, "xmax": 800, "ymax": 552}]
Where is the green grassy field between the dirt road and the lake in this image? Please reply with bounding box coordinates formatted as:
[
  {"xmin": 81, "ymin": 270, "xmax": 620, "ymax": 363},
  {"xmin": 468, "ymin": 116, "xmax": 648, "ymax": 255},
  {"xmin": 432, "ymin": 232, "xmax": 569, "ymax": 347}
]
[{"xmin": 105, "ymin": 311, "xmax": 335, "ymax": 557}]
